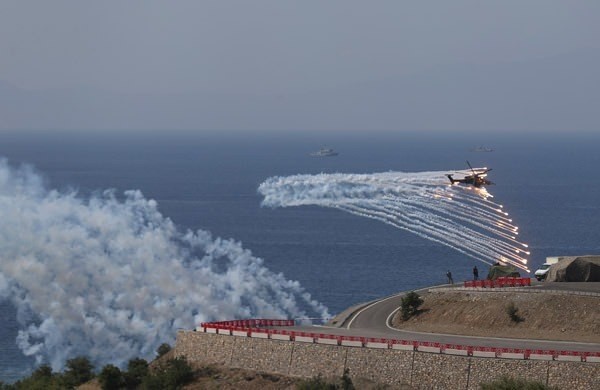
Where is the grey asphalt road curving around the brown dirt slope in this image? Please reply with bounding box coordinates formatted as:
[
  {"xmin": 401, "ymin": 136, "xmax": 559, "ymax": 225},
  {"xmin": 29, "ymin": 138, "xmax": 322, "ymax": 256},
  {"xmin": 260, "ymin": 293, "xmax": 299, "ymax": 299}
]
[{"xmin": 288, "ymin": 283, "xmax": 600, "ymax": 352}]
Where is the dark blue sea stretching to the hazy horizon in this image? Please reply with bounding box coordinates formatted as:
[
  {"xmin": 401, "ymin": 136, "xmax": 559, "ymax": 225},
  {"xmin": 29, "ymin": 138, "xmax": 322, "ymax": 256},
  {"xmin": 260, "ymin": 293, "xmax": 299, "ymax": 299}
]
[{"xmin": 0, "ymin": 129, "xmax": 600, "ymax": 382}]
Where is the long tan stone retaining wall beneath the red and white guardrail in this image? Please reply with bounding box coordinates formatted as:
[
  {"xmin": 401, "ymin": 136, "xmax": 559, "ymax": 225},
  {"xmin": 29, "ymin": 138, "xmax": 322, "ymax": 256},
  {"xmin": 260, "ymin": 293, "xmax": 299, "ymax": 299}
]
[{"xmin": 175, "ymin": 331, "xmax": 600, "ymax": 390}]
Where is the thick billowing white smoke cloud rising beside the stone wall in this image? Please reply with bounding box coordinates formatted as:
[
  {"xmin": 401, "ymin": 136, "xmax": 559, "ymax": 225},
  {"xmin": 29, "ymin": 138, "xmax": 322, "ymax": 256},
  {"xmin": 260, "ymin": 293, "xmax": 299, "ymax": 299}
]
[{"xmin": 0, "ymin": 161, "xmax": 328, "ymax": 369}]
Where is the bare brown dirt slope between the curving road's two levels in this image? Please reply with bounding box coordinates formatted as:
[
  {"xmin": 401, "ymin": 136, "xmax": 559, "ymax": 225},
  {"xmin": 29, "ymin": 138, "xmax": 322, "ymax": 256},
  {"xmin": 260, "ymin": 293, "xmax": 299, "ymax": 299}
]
[{"xmin": 393, "ymin": 292, "xmax": 600, "ymax": 343}]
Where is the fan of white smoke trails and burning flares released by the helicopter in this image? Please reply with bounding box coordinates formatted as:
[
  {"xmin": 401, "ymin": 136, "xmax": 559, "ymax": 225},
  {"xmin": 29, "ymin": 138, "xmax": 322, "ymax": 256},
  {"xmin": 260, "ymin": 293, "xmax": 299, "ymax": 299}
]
[{"xmin": 258, "ymin": 171, "xmax": 529, "ymax": 272}]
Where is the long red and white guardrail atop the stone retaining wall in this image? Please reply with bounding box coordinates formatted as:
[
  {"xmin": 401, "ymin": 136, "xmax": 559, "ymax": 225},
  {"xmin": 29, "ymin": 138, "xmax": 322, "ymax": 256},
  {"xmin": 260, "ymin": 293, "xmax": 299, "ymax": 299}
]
[{"xmin": 196, "ymin": 319, "xmax": 600, "ymax": 363}]
